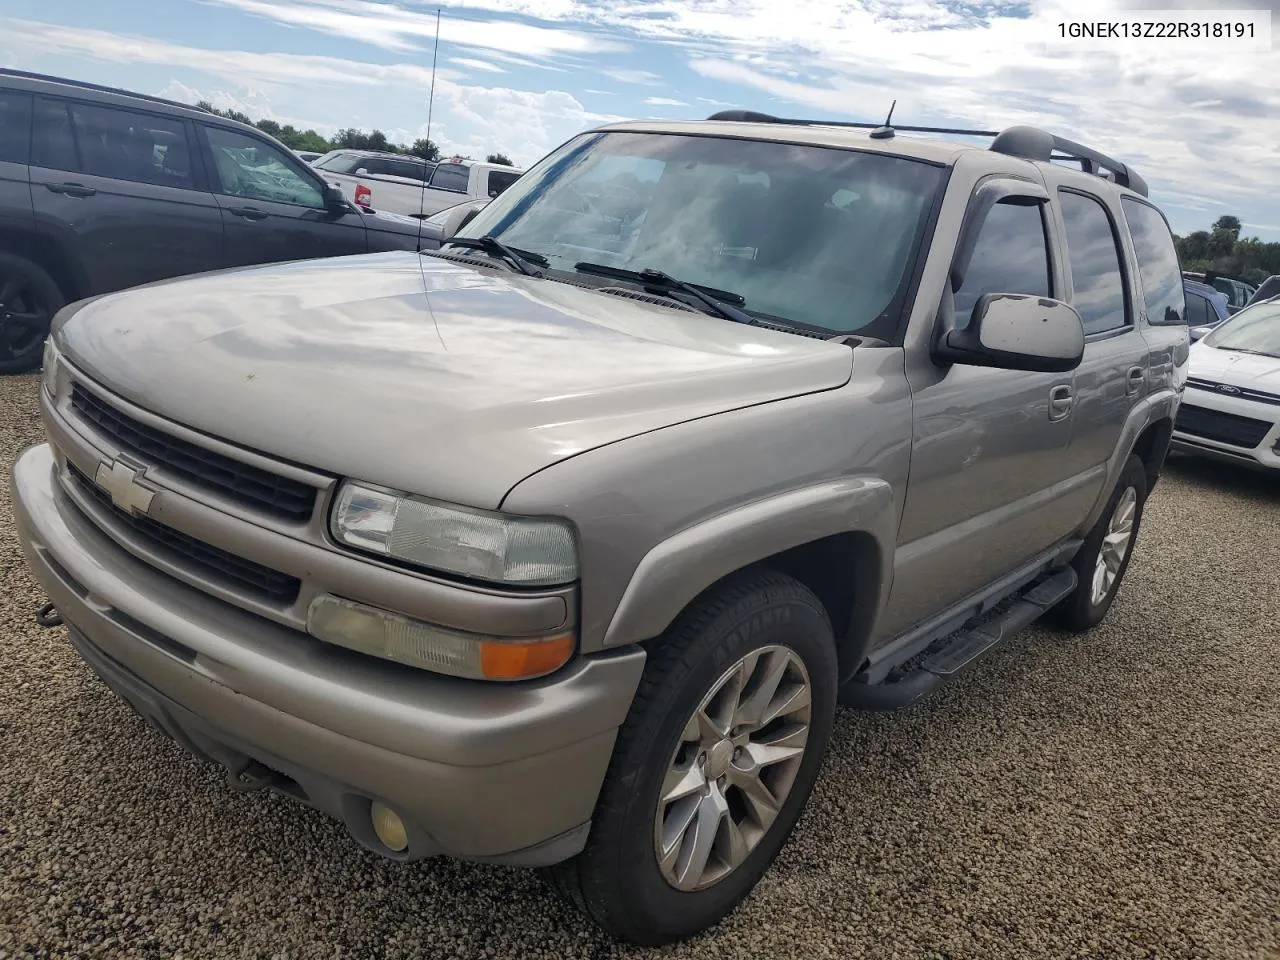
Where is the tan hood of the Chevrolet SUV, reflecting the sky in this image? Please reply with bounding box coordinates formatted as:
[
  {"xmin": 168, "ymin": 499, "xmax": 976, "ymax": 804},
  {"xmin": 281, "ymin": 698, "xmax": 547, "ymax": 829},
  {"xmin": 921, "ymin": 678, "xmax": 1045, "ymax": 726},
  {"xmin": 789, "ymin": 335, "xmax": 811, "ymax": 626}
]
[{"xmin": 54, "ymin": 252, "xmax": 852, "ymax": 508}]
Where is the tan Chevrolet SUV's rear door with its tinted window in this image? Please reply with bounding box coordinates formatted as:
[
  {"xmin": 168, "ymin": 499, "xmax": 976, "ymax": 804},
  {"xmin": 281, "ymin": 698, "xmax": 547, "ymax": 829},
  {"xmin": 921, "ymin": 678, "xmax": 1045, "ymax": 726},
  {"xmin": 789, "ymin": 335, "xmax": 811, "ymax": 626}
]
[{"xmin": 1046, "ymin": 179, "xmax": 1152, "ymax": 483}]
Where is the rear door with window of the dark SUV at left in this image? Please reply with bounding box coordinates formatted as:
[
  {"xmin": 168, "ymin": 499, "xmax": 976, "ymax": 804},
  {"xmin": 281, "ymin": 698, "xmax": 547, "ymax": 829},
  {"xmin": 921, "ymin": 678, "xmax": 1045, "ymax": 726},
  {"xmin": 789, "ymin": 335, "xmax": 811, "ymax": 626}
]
[{"xmin": 31, "ymin": 96, "xmax": 223, "ymax": 294}]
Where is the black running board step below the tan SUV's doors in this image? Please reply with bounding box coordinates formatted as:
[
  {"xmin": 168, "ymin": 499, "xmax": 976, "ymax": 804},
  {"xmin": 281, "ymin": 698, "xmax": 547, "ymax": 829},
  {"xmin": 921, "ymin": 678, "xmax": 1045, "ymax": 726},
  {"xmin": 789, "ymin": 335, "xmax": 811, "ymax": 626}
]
[{"xmin": 840, "ymin": 567, "xmax": 1078, "ymax": 712}]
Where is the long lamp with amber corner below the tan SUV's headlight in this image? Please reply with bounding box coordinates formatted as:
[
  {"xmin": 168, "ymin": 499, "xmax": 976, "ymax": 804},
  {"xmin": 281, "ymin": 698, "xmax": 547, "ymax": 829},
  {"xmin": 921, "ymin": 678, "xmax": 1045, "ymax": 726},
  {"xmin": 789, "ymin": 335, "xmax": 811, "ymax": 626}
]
[{"xmin": 307, "ymin": 595, "xmax": 575, "ymax": 680}]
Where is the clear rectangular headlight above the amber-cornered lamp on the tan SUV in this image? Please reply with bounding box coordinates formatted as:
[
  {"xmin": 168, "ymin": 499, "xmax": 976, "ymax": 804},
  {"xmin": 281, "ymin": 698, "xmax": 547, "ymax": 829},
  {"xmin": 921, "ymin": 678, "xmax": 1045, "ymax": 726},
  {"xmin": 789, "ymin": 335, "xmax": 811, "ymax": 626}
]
[{"xmin": 333, "ymin": 481, "xmax": 577, "ymax": 586}]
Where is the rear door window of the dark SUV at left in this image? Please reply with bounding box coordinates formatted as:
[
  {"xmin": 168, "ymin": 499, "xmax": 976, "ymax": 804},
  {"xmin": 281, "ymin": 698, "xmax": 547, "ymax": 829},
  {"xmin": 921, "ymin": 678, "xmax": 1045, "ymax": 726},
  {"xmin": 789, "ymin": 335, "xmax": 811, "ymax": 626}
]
[{"xmin": 69, "ymin": 104, "xmax": 195, "ymax": 189}]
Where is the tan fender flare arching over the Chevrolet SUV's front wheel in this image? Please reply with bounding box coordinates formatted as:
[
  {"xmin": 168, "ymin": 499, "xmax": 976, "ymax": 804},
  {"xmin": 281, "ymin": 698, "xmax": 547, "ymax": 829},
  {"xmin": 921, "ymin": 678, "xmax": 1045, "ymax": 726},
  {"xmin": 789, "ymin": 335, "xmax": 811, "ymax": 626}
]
[{"xmin": 604, "ymin": 476, "xmax": 897, "ymax": 646}]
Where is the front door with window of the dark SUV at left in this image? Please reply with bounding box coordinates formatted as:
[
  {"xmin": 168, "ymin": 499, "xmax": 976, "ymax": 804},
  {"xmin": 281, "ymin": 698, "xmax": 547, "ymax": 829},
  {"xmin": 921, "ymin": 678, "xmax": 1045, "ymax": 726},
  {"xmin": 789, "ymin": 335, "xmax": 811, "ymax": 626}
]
[{"xmin": 200, "ymin": 124, "xmax": 366, "ymax": 266}]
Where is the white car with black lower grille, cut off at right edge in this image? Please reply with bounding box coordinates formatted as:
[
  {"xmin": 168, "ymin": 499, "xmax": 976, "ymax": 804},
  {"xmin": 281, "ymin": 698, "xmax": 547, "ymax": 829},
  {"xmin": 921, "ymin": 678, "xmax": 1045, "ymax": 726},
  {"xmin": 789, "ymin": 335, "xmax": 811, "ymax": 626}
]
[{"xmin": 1172, "ymin": 298, "xmax": 1280, "ymax": 470}]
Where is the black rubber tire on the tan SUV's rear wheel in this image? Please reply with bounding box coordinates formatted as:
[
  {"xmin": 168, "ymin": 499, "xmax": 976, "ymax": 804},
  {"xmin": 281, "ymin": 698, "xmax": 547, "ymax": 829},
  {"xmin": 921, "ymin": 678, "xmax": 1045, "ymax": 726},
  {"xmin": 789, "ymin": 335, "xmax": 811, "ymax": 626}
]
[{"xmin": 1048, "ymin": 456, "xmax": 1147, "ymax": 632}]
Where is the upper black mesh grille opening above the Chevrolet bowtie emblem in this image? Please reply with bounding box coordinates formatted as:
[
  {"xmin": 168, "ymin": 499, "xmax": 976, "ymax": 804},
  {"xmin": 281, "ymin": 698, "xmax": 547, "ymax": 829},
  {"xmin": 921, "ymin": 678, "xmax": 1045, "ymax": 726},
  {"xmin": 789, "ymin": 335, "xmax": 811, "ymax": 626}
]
[{"xmin": 72, "ymin": 384, "xmax": 316, "ymax": 522}]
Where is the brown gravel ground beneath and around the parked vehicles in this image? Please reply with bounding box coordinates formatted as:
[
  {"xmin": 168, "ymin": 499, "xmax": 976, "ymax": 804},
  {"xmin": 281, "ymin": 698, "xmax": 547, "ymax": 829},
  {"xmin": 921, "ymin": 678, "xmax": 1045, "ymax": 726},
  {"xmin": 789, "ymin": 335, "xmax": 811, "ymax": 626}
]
[{"xmin": 0, "ymin": 378, "xmax": 1280, "ymax": 960}]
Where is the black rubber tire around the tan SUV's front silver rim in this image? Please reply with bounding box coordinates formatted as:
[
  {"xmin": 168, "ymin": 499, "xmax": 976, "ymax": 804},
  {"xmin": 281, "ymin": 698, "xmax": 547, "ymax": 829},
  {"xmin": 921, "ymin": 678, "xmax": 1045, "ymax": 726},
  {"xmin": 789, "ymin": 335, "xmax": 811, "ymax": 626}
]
[{"xmin": 547, "ymin": 571, "xmax": 837, "ymax": 946}]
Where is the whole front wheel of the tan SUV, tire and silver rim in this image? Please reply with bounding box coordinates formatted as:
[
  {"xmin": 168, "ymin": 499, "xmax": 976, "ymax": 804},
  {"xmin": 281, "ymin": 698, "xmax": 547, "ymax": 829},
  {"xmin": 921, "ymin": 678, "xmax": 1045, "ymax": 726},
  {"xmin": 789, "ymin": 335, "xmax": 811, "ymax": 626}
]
[{"xmin": 550, "ymin": 571, "xmax": 837, "ymax": 946}]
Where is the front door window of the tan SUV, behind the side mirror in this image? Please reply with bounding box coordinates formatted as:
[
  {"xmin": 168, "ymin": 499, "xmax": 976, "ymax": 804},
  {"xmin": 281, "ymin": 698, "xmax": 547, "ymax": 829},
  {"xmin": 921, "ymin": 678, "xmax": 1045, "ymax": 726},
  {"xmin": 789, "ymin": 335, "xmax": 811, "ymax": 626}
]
[{"xmin": 956, "ymin": 202, "xmax": 1051, "ymax": 320}]
